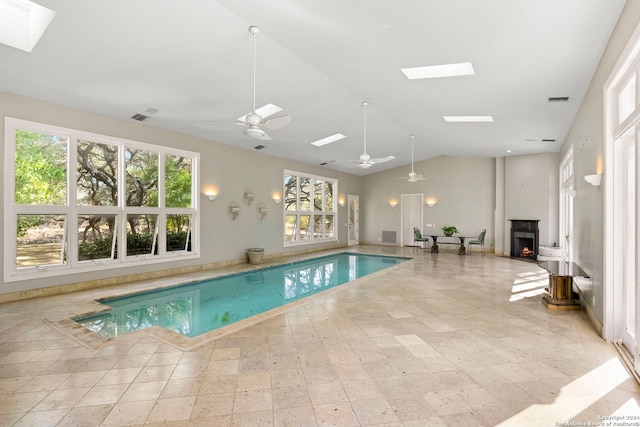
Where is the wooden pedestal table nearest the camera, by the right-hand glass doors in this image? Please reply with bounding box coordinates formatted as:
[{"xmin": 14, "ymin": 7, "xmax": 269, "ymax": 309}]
[{"xmin": 538, "ymin": 261, "xmax": 589, "ymax": 310}]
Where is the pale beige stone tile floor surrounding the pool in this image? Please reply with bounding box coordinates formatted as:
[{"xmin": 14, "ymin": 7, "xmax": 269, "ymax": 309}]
[{"xmin": 0, "ymin": 246, "xmax": 640, "ymax": 427}]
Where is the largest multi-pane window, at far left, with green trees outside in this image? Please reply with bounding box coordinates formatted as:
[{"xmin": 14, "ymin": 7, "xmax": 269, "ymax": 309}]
[{"xmin": 4, "ymin": 118, "xmax": 198, "ymax": 281}]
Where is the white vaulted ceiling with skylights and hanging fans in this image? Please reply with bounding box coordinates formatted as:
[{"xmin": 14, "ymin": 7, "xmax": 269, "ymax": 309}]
[{"xmin": 0, "ymin": 0, "xmax": 624, "ymax": 175}]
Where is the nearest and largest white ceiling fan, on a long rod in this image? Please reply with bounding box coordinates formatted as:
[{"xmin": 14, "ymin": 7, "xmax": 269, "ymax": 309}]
[{"xmin": 210, "ymin": 26, "xmax": 291, "ymax": 140}]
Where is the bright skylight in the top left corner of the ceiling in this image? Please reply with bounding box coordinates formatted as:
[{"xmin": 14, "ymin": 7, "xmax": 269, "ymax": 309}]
[{"xmin": 0, "ymin": 0, "xmax": 56, "ymax": 52}]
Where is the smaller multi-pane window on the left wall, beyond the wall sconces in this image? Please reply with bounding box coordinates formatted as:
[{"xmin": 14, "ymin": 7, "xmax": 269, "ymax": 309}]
[{"xmin": 283, "ymin": 171, "xmax": 338, "ymax": 245}]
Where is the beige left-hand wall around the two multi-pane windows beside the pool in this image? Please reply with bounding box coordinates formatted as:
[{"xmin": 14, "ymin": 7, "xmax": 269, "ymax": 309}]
[{"xmin": 0, "ymin": 93, "xmax": 360, "ymax": 294}]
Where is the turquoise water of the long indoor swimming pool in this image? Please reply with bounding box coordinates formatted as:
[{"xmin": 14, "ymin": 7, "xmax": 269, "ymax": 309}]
[{"xmin": 75, "ymin": 253, "xmax": 408, "ymax": 337}]
